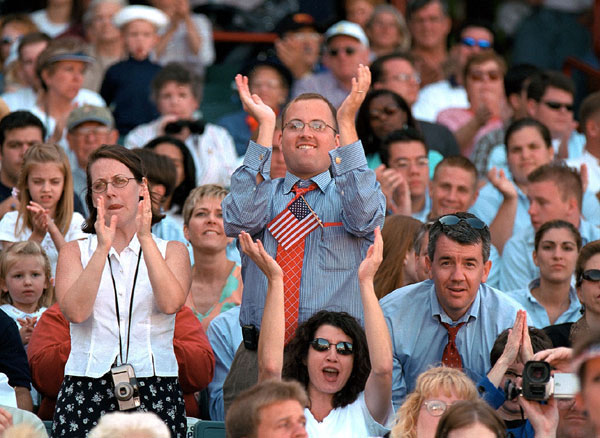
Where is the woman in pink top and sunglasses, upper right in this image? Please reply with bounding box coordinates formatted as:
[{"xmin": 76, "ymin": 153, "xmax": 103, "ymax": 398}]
[{"xmin": 437, "ymin": 51, "xmax": 508, "ymax": 157}]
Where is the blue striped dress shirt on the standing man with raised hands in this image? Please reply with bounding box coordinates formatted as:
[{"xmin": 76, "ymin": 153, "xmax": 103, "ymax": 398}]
[{"xmin": 222, "ymin": 141, "xmax": 385, "ymax": 328}]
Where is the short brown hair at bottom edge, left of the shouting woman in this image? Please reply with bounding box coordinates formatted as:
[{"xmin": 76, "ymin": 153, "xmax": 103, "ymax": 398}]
[{"xmin": 225, "ymin": 380, "xmax": 308, "ymax": 438}]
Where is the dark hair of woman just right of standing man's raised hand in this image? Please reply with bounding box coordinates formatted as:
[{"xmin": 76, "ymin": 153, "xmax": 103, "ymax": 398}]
[{"xmin": 356, "ymin": 89, "xmax": 419, "ymax": 155}]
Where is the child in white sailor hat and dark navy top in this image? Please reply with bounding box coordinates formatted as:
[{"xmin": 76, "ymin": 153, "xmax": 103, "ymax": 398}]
[{"xmin": 100, "ymin": 5, "xmax": 169, "ymax": 136}]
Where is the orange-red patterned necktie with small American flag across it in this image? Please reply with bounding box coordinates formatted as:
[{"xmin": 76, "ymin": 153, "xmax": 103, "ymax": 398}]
[{"xmin": 267, "ymin": 183, "xmax": 319, "ymax": 344}]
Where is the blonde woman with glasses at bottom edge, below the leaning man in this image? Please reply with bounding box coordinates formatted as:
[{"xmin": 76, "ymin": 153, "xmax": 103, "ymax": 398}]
[{"xmin": 391, "ymin": 367, "xmax": 479, "ymax": 438}]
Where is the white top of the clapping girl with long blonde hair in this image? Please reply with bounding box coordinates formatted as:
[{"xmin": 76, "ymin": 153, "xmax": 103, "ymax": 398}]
[{"xmin": 0, "ymin": 211, "xmax": 88, "ymax": 276}]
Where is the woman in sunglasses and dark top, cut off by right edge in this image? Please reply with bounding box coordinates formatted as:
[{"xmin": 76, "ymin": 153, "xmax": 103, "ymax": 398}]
[{"xmin": 544, "ymin": 240, "xmax": 600, "ymax": 347}]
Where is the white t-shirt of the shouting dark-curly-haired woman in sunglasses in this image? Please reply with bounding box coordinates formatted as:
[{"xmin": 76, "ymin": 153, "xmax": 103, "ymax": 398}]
[{"xmin": 304, "ymin": 392, "xmax": 394, "ymax": 438}]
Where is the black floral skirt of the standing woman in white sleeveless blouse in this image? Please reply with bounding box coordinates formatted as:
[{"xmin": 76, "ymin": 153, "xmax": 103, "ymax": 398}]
[{"xmin": 52, "ymin": 372, "xmax": 186, "ymax": 438}]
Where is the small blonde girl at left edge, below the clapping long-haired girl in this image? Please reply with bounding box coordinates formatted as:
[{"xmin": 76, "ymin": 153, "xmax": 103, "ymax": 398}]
[{"xmin": 0, "ymin": 241, "xmax": 54, "ymax": 345}]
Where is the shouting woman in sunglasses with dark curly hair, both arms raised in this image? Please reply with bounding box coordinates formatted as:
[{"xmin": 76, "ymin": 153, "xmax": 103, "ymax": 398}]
[{"xmin": 240, "ymin": 229, "xmax": 393, "ymax": 438}]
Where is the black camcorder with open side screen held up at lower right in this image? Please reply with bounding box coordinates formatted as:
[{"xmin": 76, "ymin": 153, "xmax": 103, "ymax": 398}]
[{"xmin": 504, "ymin": 360, "xmax": 579, "ymax": 401}]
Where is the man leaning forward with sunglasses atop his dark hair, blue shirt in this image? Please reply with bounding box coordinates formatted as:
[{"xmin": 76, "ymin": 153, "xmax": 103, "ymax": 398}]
[{"xmin": 380, "ymin": 213, "xmax": 519, "ymax": 407}]
